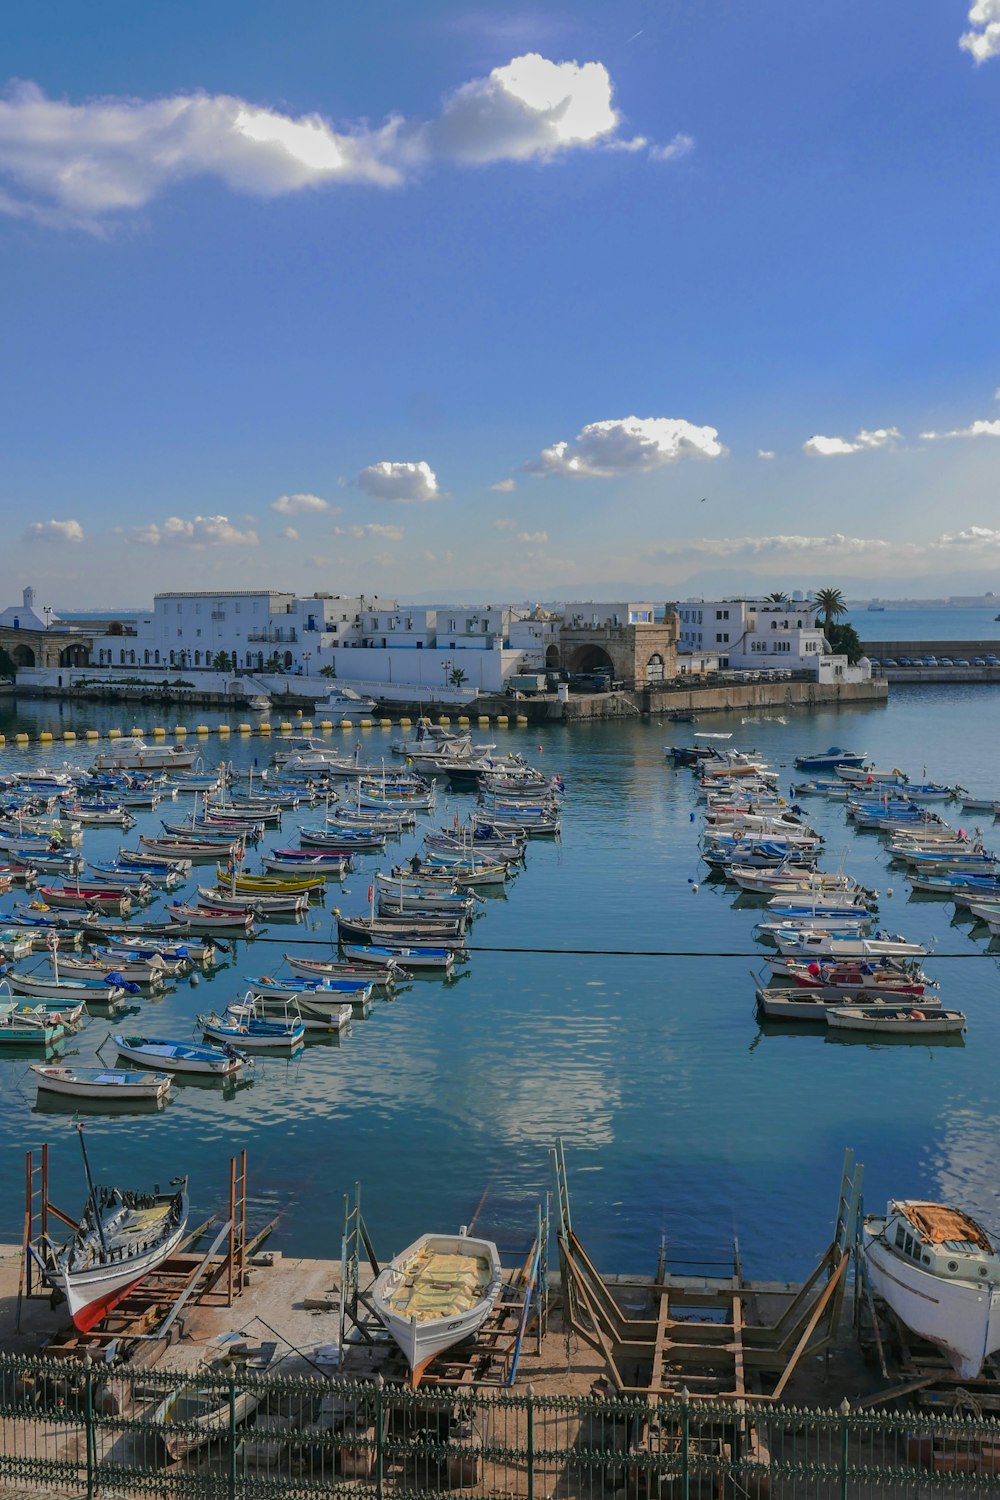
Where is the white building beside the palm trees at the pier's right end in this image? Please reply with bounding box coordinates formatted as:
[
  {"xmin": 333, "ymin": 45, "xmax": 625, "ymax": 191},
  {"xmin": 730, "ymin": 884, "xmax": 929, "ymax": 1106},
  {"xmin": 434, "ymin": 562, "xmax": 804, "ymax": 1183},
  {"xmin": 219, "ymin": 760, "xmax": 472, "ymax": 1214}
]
[{"xmin": 678, "ymin": 599, "xmax": 871, "ymax": 683}]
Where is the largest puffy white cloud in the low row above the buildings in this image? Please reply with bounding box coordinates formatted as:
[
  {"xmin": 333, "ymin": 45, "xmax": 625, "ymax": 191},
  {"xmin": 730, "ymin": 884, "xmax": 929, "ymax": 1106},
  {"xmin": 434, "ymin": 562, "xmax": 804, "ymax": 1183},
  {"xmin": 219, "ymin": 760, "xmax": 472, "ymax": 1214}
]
[{"xmin": 525, "ymin": 417, "xmax": 726, "ymax": 479}]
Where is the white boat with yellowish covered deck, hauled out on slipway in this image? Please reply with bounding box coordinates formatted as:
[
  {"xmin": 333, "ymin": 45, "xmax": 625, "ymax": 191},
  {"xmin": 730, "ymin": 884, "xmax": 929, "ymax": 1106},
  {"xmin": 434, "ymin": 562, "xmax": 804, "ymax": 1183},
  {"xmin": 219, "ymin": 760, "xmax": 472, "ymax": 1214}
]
[{"xmin": 372, "ymin": 1235, "xmax": 502, "ymax": 1382}]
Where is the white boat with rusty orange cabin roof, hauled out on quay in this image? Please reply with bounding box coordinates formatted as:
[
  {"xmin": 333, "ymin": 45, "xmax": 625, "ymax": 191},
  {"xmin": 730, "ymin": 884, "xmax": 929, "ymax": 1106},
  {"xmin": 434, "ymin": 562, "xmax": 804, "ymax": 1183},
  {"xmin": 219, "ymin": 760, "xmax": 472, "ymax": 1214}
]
[{"xmin": 862, "ymin": 1199, "xmax": 1000, "ymax": 1380}]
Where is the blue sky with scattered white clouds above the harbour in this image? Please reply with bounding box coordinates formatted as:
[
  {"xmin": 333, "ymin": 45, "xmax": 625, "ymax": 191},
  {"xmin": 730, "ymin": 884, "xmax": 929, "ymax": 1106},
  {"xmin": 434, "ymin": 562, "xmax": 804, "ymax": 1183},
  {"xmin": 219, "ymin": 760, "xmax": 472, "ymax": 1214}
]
[{"xmin": 0, "ymin": 0, "xmax": 1000, "ymax": 609}]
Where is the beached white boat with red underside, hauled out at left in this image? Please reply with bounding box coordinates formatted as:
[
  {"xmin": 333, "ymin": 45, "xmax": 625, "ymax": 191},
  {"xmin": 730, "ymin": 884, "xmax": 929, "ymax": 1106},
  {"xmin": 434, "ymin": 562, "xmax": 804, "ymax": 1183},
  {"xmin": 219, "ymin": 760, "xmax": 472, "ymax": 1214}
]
[{"xmin": 48, "ymin": 1134, "xmax": 187, "ymax": 1334}]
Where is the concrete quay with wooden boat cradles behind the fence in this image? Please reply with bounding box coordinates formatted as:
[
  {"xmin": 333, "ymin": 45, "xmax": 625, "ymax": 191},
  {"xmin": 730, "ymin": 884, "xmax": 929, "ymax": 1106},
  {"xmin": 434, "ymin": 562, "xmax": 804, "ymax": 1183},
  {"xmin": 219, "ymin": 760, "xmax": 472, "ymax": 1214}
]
[{"xmin": 0, "ymin": 1142, "xmax": 1000, "ymax": 1500}]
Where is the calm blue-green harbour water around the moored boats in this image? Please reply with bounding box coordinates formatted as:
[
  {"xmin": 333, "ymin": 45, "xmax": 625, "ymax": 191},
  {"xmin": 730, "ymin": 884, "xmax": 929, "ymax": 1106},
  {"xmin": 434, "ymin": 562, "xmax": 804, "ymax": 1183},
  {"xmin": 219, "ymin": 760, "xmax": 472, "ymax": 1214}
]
[{"xmin": 0, "ymin": 687, "xmax": 1000, "ymax": 1275}]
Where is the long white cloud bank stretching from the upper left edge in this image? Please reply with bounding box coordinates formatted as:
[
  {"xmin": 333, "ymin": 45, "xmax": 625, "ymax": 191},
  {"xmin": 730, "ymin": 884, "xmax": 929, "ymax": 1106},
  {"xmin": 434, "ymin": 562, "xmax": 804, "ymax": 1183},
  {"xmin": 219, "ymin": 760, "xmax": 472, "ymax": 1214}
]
[{"xmin": 0, "ymin": 53, "xmax": 677, "ymax": 230}]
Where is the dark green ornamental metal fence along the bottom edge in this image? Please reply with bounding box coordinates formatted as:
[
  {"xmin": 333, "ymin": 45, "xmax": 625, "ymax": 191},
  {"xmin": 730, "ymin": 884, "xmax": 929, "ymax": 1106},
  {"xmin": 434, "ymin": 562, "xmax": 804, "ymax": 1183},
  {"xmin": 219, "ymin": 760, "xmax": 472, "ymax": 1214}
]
[{"xmin": 0, "ymin": 1356, "xmax": 1000, "ymax": 1500}]
